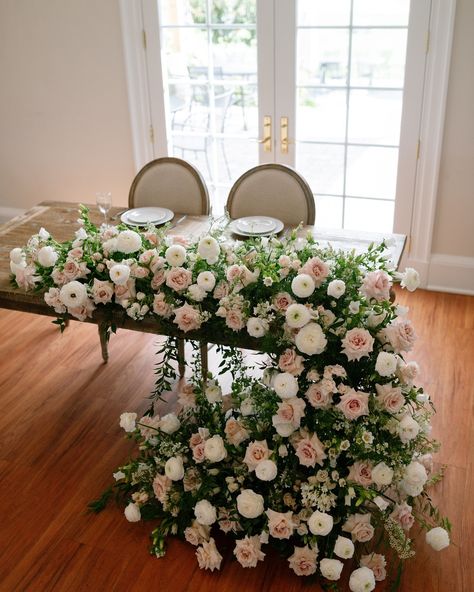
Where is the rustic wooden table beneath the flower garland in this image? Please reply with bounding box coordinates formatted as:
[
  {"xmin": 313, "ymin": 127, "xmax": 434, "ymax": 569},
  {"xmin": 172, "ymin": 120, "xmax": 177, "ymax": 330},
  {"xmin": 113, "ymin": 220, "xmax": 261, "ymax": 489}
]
[{"xmin": 0, "ymin": 201, "xmax": 406, "ymax": 373}]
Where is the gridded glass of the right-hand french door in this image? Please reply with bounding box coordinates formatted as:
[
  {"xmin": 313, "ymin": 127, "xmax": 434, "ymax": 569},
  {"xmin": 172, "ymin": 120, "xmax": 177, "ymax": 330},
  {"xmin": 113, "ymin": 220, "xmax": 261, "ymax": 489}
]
[{"xmin": 295, "ymin": 0, "xmax": 410, "ymax": 232}]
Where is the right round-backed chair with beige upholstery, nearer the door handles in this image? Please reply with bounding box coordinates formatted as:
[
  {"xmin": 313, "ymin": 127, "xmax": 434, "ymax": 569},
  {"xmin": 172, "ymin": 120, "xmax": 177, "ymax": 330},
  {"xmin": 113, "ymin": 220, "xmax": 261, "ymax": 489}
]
[{"xmin": 227, "ymin": 165, "xmax": 314, "ymax": 226}]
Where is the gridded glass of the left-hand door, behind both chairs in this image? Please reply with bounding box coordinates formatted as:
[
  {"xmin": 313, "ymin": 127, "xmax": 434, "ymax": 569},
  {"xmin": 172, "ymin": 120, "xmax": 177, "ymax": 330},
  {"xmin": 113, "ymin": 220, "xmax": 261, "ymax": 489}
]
[{"xmin": 158, "ymin": 0, "xmax": 259, "ymax": 213}]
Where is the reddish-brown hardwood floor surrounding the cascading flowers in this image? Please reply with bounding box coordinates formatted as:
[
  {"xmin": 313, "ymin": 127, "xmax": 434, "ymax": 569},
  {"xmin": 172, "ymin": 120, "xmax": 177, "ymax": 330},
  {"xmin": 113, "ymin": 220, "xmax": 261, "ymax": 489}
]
[{"xmin": 0, "ymin": 291, "xmax": 474, "ymax": 592}]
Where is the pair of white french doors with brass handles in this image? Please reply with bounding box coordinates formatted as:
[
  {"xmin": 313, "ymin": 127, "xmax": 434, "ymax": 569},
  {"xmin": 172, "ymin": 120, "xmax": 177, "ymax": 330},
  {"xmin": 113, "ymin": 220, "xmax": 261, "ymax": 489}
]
[{"xmin": 142, "ymin": 0, "xmax": 430, "ymax": 234}]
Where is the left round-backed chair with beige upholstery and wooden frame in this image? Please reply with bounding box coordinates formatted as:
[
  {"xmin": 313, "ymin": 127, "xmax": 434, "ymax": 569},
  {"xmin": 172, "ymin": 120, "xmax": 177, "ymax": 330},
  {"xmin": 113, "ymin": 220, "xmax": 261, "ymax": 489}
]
[{"xmin": 129, "ymin": 158, "xmax": 209, "ymax": 215}]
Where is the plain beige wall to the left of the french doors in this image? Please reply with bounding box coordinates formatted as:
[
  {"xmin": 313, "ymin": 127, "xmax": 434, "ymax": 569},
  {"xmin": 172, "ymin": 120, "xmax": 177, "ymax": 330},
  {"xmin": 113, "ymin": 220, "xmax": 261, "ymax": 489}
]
[{"xmin": 0, "ymin": 0, "xmax": 134, "ymax": 215}]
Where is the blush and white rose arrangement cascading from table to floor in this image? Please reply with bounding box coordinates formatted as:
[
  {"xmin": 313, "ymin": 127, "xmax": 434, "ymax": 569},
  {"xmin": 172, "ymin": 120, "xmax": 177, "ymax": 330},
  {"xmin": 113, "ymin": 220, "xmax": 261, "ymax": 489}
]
[{"xmin": 11, "ymin": 208, "xmax": 450, "ymax": 592}]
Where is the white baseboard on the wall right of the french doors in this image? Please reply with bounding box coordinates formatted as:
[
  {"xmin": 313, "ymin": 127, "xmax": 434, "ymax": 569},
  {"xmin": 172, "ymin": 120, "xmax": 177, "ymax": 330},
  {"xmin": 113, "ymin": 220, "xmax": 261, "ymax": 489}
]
[{"xmin": 426, "ymin": 253, "xmax": 474, "ymax": 295}]
